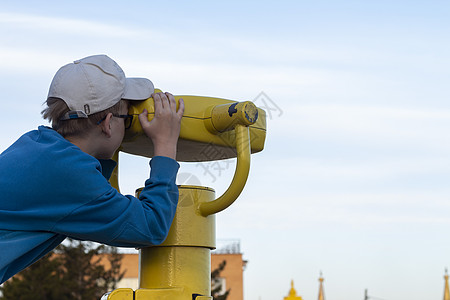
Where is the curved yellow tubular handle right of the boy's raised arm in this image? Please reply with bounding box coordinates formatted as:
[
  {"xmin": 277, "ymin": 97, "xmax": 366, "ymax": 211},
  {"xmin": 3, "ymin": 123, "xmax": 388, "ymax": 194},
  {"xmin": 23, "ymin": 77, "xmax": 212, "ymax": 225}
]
[{"xmin": 199, "ymin": 124, "xmax": 250, "ymax": 217}]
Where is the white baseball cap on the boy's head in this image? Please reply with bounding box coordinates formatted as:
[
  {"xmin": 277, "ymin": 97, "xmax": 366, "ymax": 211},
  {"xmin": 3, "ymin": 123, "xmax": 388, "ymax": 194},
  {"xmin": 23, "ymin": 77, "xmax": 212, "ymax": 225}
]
[{"xmin": 48, "ymin": 55, "xmax": 155, "ymax": 118}]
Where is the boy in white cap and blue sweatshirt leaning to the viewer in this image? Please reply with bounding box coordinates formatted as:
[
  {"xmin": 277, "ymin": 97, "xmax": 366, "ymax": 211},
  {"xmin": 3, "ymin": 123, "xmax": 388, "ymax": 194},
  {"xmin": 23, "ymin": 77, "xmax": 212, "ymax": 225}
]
[{"xmin": 0, "ymin": 55, "xmax": 184, "ymax": 284}]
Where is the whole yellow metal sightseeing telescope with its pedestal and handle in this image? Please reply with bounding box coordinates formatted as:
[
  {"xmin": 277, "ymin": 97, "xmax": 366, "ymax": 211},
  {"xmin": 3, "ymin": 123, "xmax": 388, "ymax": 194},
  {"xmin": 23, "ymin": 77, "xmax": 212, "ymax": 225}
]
[{"xmin": 107, "ymin": 89, "xmax": 266, "ymax": 300}]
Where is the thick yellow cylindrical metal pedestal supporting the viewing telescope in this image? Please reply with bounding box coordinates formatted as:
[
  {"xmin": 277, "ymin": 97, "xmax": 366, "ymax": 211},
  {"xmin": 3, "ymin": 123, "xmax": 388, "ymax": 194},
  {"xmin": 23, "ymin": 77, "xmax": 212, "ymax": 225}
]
[{"xmin": 108, "ymin": 186, "xmax": 215, "ymax": 300}]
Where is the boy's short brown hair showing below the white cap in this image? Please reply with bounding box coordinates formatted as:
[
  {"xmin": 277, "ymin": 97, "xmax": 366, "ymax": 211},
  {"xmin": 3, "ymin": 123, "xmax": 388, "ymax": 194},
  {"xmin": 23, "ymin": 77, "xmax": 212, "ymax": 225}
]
[{"xmin": 41, "ymin": 97, "xmax": 128, "ymax": 137}]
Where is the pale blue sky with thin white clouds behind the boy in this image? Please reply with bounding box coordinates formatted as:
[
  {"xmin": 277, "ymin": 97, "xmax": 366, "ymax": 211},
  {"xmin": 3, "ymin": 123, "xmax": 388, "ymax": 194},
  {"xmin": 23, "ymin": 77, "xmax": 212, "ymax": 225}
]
[{"xmin": 0, "ymin": 0, "xmax": 450, "ymax": 300}]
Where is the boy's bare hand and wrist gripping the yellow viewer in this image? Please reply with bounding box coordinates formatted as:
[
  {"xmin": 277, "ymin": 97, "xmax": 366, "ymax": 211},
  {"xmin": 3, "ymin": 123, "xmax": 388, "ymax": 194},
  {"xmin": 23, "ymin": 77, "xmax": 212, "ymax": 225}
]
[{"xmin": 139, "ymin": 93, "xmax": 184, "ymax": 159}]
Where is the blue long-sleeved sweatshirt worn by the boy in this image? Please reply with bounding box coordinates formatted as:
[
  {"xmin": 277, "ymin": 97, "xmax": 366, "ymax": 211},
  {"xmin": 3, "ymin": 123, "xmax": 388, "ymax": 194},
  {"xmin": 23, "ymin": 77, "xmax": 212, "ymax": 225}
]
[{"xmin": 0, "ymin": 126, "xmax": 179, "ymax": 283}]
